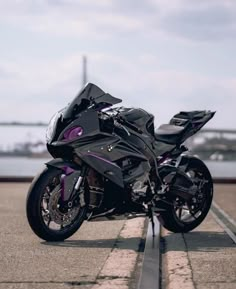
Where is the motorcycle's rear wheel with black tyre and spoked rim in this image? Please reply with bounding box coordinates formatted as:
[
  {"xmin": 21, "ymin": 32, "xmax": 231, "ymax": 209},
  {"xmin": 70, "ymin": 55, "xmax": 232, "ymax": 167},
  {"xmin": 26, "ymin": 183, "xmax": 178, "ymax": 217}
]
[{"xmin": 158, "ymin": 157, "xmax": 213, "ymax": 233}]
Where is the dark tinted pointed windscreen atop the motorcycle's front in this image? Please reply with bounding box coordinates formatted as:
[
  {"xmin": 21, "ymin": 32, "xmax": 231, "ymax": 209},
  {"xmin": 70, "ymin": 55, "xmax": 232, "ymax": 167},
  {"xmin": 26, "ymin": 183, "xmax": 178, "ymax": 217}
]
[{"xmin": 63, "ymin": 83, "xmax": 122, "ymax": 119}]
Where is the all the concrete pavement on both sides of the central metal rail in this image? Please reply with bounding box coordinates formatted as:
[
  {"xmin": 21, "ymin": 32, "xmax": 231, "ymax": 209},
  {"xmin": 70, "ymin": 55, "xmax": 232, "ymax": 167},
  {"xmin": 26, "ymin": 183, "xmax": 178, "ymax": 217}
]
[{"xmin": 0, "ymin": 183, "xmax": 236, "ymax": 289}]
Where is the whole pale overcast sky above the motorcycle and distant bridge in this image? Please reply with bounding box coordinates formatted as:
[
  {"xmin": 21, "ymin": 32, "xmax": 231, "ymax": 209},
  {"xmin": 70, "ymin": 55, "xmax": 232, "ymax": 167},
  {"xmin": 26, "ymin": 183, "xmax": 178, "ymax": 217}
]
[{"xmin": 0, "ymin": 0, "xmax": 236, "ymax": 129}]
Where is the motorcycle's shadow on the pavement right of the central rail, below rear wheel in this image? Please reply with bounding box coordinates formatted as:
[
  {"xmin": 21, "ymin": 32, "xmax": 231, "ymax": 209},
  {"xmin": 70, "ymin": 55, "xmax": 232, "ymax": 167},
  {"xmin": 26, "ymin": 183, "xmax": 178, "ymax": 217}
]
[{"xmin": 161, "ymin": 231, "xmax": 236, "ymax": 252}]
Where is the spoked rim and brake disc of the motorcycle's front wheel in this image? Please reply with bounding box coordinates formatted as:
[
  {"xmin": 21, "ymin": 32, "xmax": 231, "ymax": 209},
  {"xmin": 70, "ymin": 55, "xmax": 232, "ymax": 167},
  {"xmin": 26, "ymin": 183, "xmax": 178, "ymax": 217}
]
[{"xmin": 40, "ymin": 174, "xmax": 80, "ymax": 232}]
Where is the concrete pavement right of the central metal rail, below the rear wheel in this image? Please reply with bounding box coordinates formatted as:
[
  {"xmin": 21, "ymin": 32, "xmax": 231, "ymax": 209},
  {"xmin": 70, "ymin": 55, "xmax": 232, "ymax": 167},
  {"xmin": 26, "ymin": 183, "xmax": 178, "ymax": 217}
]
[{"xmin": 162, "ymin": 185, "xmax": 236, "ymax": 289}]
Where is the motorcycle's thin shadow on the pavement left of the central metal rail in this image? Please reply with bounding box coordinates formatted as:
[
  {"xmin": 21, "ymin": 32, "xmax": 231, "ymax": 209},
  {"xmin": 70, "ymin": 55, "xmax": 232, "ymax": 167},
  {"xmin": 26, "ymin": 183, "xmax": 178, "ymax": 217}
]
[{"xmin": 41, "ymin": 238, "xmax": 145, "ymax": 252}]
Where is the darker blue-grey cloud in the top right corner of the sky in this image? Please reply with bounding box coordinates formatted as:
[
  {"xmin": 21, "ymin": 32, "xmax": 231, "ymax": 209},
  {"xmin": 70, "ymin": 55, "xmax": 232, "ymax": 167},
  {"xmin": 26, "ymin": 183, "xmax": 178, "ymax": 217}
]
[{"xmin": 154, "ymin": 0, "xmax": 236, "ymax": 42}]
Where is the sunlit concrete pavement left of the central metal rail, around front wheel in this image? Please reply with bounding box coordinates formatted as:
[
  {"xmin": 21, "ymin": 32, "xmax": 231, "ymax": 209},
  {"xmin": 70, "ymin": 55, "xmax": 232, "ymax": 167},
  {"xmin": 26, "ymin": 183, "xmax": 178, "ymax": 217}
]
[{"xmin": 0, "ymin": 183, "xmax": 144, "ymax": 289}]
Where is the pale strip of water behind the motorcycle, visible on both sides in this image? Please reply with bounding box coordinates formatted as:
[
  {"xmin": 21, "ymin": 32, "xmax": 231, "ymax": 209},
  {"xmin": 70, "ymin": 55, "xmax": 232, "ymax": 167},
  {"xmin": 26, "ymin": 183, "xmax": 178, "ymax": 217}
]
[{"xmin": 0, "ymin": 157, "xmax": 236, "ymax": 178}]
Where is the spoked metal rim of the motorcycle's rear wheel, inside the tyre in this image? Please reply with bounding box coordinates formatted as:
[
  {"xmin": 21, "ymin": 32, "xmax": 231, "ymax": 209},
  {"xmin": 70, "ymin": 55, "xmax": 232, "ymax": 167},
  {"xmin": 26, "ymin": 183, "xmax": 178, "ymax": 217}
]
[{"xmin": 174, "ymin": 169, "xmax": 209, "ymax": 224}]
